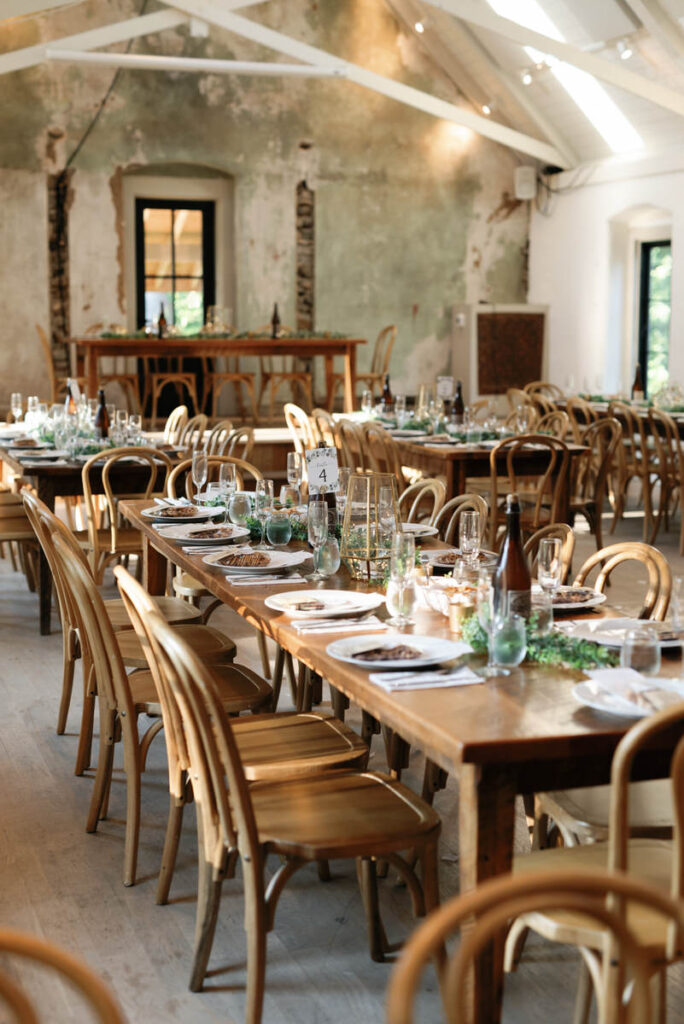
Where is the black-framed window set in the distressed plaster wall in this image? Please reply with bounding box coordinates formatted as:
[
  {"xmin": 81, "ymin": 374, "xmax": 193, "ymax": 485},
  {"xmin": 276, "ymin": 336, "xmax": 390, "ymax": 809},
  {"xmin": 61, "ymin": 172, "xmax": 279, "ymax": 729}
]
[{"xmin": 135, "ymin": 199, "xmax": 216, "ymax": 334}]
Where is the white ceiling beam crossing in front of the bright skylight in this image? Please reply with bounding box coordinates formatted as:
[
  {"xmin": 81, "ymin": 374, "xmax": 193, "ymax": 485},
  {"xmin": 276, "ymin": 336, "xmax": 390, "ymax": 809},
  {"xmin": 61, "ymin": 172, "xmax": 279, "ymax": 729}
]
[{"xmin": 425, "ymin": 0, "xmax": 684, "ymax": 117}]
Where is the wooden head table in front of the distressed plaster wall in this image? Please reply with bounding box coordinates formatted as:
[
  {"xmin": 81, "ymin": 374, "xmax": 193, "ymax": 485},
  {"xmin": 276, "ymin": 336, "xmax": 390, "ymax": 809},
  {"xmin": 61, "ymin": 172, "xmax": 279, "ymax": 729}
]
[{"xmin": 70, "ymin": 337, "xmax": 366, "ymax": 413}]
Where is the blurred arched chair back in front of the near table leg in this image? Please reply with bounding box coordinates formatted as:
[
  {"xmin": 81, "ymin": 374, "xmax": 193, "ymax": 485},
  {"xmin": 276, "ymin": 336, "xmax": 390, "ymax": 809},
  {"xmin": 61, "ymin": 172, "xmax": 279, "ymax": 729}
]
[{"xmin": 385, "ymin": 865, "xmax": 682, "ymax": 1024}]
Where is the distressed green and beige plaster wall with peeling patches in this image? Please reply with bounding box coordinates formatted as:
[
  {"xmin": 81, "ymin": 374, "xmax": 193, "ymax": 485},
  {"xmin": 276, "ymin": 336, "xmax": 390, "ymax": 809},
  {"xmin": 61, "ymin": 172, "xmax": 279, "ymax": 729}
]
[{"xmin": 0, "ymin": 0, "xmax": 527, "ymax": 401}]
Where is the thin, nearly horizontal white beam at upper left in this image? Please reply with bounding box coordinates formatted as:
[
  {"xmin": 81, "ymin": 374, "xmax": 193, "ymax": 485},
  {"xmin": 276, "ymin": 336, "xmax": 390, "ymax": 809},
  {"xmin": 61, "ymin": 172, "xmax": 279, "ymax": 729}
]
[{"xmin": 45, "ymin": 47, "xmax": 344, "ymax": 78}]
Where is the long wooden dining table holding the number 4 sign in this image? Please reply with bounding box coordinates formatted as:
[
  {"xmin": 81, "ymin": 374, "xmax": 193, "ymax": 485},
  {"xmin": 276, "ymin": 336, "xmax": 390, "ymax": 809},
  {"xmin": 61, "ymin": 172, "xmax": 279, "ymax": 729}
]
[{"xmin": 121, "ymin": 493, "xmax": 679, "ymax": 1024}]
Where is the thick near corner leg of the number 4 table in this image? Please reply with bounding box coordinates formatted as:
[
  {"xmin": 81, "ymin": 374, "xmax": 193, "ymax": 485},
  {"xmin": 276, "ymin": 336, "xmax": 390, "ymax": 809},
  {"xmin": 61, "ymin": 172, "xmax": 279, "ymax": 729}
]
[{"xmin": 459, "ymin": 764, "xmax": 516, "ymax": 1024}]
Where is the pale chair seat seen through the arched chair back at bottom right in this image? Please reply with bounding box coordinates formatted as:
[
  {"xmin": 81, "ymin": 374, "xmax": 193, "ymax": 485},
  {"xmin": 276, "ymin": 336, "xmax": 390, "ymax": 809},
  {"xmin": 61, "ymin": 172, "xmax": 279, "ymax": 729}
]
[{"xmin": 513, "ymin": 839, "xmax": 674, "ymax": 953}]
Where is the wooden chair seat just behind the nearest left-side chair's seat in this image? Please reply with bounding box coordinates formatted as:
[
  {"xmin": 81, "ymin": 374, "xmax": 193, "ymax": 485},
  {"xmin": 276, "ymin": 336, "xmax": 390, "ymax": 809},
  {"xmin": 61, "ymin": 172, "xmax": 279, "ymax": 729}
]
[{"xmin": 231, "ymin": 712, "xmax": 369, "ymax": 781}]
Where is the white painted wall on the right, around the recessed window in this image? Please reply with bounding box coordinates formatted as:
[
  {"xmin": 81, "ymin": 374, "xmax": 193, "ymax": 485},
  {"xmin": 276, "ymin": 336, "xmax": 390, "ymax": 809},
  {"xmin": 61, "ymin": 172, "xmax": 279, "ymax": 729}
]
[{"xmin": 528, "ymin": 158, "xmax": 684, "ymax": 391}]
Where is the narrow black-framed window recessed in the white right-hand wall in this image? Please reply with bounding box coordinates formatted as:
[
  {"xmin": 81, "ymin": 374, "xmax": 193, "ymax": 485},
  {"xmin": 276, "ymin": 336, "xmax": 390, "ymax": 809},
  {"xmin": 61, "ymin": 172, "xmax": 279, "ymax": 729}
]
[{"xmin": 639, "ymin": 240, "xmax": 672, "ymax": 395}]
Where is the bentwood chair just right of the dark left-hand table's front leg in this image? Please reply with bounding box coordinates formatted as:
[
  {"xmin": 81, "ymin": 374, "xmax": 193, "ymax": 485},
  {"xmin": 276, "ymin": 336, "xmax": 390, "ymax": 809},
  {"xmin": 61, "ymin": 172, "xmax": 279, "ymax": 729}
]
[{"xmin": 81, "ymin": 446, "xmax": 171, "ymax": 584}]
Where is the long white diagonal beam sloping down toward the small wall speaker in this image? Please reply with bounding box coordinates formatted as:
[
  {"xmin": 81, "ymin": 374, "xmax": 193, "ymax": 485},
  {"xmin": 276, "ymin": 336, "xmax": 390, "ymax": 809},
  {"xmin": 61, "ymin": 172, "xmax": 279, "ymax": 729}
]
[{"xmin": 167, "ymin": 0, "xmax": 567, "ymax": 167}]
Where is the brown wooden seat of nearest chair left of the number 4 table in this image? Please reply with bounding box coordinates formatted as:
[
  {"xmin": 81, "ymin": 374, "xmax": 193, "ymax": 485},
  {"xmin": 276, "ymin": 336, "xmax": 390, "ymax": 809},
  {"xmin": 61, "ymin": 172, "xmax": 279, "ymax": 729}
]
[{"xmin": 250, "ymin": 772, "xmax": 439, "ymax": 860}]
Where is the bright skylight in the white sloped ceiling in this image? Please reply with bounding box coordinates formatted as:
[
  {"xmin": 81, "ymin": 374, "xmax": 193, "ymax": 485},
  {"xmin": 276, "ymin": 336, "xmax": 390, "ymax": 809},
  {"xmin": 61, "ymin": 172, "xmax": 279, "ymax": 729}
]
[{"xmin": 487, "ymin": 0, "xmax": 644, "ymax": 153}]
